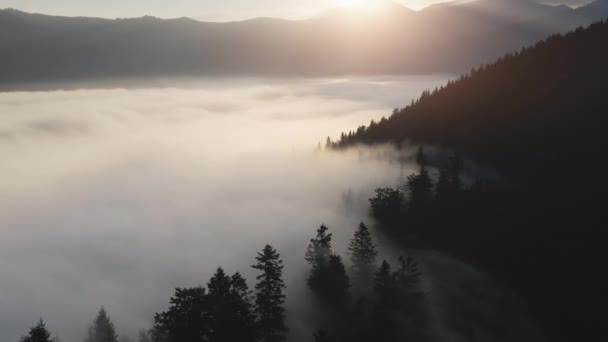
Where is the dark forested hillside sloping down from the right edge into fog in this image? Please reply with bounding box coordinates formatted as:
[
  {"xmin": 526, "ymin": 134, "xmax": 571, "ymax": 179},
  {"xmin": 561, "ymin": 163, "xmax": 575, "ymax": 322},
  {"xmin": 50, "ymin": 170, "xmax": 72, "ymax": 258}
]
[{"xmin": 327, "ymin": 21, "xmax": 608, "ymax": 341}]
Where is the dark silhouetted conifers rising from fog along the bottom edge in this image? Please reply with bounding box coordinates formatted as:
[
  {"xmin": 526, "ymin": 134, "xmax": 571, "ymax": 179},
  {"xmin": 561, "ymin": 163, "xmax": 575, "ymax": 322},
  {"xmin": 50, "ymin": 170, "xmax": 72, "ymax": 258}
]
[{"xmin": 21, "ymin": 223, "xmax": 430, "ymax": 342}]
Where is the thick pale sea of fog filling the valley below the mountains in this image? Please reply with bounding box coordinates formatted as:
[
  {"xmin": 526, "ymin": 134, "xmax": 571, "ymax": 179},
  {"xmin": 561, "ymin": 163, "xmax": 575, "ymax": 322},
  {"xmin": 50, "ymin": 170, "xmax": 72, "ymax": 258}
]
[{"xmin": 0, "ymin": 76, "xmax": 540, "ymax": 342}]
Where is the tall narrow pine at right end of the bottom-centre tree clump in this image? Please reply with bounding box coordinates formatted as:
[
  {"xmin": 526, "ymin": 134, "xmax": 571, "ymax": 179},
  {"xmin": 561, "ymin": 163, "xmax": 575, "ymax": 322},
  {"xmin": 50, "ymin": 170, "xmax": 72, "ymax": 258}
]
[{"xmin": 251, "ymin": 245, "xmax": 287, "ymax": 342}]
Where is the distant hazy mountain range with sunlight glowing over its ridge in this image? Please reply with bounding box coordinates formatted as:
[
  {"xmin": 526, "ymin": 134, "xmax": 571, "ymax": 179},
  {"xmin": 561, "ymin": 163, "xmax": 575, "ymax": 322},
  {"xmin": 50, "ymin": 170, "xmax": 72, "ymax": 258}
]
[{"xmin": 0, "ymin": 0, "xmax": 608, "ymax": 88}]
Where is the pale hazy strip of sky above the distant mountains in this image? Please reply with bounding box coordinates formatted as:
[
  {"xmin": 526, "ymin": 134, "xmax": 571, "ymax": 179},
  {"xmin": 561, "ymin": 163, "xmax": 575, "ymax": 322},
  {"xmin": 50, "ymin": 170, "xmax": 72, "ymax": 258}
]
[{"xmin": 0, "ymin": 0, "xmax": 452, "ymax": 21}]
